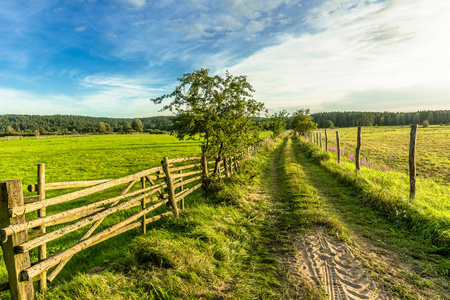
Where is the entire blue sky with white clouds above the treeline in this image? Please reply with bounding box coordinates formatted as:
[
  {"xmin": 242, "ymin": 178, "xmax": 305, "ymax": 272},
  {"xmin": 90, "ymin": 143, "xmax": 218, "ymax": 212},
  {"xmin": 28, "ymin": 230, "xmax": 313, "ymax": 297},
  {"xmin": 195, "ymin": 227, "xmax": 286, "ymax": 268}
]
[{"xmin": 0, "ymin": 0, "xmax": 450, "ymax": 117}]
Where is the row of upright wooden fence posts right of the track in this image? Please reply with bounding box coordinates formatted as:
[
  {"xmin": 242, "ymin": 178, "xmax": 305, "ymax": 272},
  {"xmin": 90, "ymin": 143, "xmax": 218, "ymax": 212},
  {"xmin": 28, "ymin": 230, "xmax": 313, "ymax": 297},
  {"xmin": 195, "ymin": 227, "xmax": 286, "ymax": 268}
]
[{"xmin": 304, "ymin": 124, "xmax": 418, "ymax": 199}]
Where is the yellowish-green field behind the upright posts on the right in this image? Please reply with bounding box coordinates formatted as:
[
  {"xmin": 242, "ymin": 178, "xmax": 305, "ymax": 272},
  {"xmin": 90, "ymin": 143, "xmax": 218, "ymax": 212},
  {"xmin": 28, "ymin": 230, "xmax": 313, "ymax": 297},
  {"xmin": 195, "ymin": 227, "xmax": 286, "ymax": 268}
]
[{"xmin": 320, "ymin": 126, "xmax": 450, "ymax": 185}]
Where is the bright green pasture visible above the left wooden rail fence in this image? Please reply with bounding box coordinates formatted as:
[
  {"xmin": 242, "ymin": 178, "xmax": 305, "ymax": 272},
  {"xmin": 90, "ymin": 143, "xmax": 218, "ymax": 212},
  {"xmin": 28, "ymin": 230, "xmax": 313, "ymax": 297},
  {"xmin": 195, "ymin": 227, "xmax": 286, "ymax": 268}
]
[{"xmin": 0, "ymin": 135, "xmax": 201, "ymax": 185}]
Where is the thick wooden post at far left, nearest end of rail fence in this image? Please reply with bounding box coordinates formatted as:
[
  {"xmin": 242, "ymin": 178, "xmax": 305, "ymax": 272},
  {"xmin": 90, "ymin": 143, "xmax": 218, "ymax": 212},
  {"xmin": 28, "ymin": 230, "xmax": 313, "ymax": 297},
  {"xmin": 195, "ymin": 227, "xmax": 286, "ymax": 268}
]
[{"xmin": 0, "ymin": 180, "xmax": 34, "ymax": 300}]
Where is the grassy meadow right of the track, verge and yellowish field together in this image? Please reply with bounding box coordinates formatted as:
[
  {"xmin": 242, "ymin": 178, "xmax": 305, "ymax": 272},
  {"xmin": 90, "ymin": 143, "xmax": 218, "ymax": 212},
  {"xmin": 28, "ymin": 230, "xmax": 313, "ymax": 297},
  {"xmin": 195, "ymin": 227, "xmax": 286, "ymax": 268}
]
[{"xmin": 302, "ymin": 127, "xmax": 450, "ymax": 253}]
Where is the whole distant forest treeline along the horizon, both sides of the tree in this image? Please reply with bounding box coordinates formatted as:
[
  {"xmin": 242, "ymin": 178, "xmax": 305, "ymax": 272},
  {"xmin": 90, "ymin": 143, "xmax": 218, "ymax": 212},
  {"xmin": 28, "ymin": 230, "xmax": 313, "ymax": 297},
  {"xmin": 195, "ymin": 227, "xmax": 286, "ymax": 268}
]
[{"xmin": 0, "ymin": 110, "xmax": 450, "ymax": 136}]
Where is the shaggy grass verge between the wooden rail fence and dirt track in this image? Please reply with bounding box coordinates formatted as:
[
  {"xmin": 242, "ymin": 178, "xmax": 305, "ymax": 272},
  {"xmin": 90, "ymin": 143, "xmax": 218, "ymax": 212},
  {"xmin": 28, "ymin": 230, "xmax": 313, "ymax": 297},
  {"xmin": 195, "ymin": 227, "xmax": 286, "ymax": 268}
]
[{"xmin": 35, "ymin": 138, "xmax": 296, "ymax": 299}]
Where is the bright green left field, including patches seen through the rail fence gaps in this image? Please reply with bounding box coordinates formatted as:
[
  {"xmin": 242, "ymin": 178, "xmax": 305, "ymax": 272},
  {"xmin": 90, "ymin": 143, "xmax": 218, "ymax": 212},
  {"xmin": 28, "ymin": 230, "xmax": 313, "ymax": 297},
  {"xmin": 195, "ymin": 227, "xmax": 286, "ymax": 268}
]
[{"xmin": 0, "ymin": 135, "xmax": 201, "ymax": 294}]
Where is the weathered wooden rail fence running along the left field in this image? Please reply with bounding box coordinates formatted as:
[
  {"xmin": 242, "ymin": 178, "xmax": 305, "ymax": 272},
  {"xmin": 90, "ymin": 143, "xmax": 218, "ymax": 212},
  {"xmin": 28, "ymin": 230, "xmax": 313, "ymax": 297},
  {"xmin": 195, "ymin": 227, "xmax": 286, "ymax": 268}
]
[{"xmin": 0, "ymin": 138, "xmax": 267, "ymax": 299}]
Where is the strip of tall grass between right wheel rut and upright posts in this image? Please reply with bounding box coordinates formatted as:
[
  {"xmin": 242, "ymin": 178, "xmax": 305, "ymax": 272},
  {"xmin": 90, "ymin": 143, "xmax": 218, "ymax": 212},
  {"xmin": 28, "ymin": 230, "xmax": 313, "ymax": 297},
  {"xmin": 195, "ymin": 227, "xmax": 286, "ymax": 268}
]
[{"xmin": 299, "ymin": 139, "xmax": 450, "ymax": 255}]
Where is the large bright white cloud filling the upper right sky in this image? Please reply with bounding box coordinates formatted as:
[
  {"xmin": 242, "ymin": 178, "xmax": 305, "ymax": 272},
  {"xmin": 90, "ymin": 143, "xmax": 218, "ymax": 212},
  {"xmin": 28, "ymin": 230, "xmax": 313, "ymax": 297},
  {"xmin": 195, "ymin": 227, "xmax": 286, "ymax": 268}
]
[{"xmin": 222, "ymin": 0, "xmax": 450, "ymax": 110}]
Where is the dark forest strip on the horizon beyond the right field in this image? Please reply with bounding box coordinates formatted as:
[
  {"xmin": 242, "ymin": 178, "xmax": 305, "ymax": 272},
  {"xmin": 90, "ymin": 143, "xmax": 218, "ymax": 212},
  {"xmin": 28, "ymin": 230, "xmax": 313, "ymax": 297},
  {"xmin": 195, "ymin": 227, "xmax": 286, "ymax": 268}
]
[{"xmin": 311, "ymin": 110, "xmax": 450, "ymax": 128}]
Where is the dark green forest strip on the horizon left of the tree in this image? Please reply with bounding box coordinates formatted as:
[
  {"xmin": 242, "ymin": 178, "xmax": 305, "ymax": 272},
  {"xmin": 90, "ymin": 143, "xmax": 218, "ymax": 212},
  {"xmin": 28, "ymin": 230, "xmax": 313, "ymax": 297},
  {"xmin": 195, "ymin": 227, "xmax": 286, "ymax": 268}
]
[{"xmin": 0, "ymin": 115, "xmax": 173, "ymax": 136}]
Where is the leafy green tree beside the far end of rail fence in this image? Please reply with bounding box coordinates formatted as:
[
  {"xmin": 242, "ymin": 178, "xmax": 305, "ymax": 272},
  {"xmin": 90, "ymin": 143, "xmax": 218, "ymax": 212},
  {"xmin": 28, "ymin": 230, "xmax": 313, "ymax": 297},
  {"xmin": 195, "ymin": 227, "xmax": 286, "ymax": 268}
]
[{"xmin": 150, "ymin": 69, "xmax": 264, "ymax": 172}]
